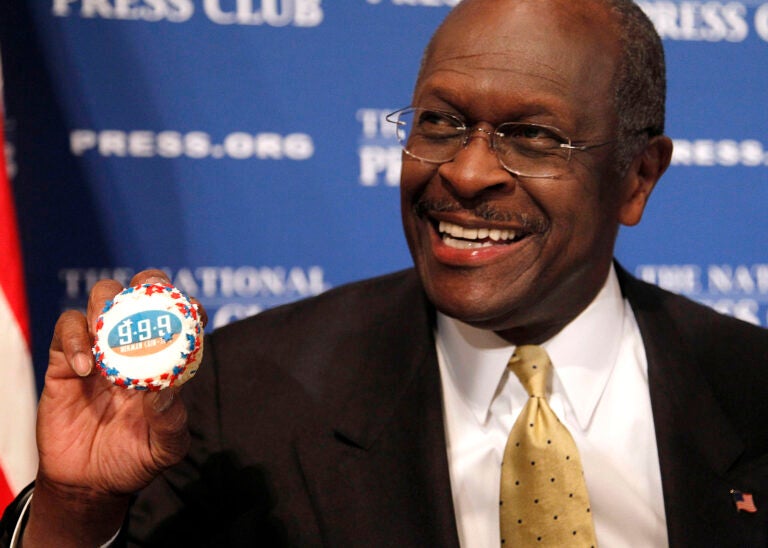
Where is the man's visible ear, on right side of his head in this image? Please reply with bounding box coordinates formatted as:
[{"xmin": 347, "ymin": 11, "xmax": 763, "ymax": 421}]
[{"xmin": 619, "ymin": 135, "xmax": 672, "ymax": 226}]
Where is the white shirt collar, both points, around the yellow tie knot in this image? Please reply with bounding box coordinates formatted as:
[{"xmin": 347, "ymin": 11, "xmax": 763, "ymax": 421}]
[{"xmin": 437, "ymin": 267, "xmax": 625, "ymax": 429}]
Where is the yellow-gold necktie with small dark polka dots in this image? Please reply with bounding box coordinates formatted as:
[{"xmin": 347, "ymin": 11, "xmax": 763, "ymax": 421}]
[{"xmin": 499, "ymin": 345, "xmax": 597, "ymax": 547}]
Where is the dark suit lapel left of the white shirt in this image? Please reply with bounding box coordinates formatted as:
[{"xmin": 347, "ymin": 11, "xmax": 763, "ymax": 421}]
[{"xmin": 296, "ymin": 272, "xmax": 457, "ymax": 547}]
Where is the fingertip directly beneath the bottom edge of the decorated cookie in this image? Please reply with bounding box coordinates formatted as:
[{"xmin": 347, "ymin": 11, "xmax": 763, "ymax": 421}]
[{"xmin": 144, "ymin": 388, "xmax": 190, "ymax": 468}]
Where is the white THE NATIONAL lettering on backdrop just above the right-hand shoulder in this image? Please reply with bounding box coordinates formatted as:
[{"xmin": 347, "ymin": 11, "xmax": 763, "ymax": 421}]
[{"xmin": 635, "ymin": 264, "xmax": 768, "ymax": 326}]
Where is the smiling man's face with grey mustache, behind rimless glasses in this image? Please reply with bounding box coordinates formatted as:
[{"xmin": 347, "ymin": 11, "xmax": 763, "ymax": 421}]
[{"xmin": 401, "ymin": 0, "xmax": 640, "ymax": 343}]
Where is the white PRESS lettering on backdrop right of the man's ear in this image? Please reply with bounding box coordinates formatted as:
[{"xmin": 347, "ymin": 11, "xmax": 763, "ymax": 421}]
[{"xmin": 672, "ymin": 139, "xmax": 768, "ymax": 167}]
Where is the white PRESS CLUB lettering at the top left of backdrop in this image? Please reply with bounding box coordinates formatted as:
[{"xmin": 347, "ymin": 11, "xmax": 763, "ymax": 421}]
[{"xmin": 51, "ymin": 0, "xmax": 324, "ymax": 27}]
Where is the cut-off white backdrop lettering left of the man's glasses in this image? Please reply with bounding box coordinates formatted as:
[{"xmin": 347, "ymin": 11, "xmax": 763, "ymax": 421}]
[{"xmin": 357, "ymin": 108, "xmax": 402, "ymax": 186}]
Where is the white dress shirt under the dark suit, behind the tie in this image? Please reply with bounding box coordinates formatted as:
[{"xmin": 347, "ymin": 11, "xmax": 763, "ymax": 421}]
[{"xmin": 437, "ymin": 269, "xmax": 668, "ymax": 548}]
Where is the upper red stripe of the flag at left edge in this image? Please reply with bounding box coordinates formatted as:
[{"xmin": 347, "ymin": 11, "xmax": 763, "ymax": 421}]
[{"xmin": 0, "ymin": 114, "xmax": 30, "ymax": 347}]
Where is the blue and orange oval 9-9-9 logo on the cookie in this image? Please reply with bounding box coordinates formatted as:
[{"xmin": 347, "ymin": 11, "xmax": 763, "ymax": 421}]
[{"xmin": 107, "ymin": 310, "xmax": 181, "ymax": 356}]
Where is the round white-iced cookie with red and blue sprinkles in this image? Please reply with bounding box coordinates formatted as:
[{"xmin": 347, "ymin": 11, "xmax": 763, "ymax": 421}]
[{"xmin": 93, "ymin": 284, "xmax": 203, "ymax": 391}]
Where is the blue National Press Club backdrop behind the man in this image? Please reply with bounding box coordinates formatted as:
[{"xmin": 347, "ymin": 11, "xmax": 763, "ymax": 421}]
[{"xmin": 0, "ymin": 0, "xmax": 768, "ymax": 394}]
